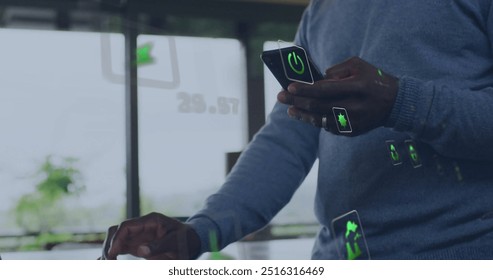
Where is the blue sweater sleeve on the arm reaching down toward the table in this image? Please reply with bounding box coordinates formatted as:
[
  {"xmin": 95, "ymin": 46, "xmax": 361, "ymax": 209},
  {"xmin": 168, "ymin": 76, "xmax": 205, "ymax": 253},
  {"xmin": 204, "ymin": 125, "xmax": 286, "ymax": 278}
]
[{"xmin": 188, "ymin": 103, "xmax": 320, "ymax": 253}]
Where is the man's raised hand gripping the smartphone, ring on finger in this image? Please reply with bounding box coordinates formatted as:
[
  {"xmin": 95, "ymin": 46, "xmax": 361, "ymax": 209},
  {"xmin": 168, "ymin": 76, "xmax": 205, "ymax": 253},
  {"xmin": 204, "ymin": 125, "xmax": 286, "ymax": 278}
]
[{"xmin": 277, "ymin": 57, "xmax": 399, "ymax": 136}]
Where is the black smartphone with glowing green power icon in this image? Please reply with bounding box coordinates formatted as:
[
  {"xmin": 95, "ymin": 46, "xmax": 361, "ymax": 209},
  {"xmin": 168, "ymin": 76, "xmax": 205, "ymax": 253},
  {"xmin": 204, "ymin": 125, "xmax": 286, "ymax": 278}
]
[{"xmin": 260, "ymin": 46, "xmax": 324, "ymax": 90}]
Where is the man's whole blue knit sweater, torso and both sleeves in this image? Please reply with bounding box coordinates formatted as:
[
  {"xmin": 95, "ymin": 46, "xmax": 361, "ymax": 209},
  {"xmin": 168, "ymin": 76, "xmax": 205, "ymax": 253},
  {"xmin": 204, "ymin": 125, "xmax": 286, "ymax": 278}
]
[{"xmin": 188, "ymin": 0, "xmax": 493, "ymax": 259}]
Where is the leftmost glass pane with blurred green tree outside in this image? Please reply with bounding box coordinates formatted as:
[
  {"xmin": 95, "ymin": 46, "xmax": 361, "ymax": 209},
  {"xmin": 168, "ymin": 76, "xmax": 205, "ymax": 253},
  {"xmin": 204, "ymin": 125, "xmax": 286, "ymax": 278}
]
[{"xmin": 0, "ymin": 29, "xmax": 125, "ymax": 250}]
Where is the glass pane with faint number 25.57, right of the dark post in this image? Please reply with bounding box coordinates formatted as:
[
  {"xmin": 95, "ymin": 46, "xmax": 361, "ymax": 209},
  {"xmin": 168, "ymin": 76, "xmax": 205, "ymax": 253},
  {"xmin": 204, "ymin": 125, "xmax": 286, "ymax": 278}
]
[{"xmin": 138, "ymin": 35, "xmax": 247, "ymax": 216}]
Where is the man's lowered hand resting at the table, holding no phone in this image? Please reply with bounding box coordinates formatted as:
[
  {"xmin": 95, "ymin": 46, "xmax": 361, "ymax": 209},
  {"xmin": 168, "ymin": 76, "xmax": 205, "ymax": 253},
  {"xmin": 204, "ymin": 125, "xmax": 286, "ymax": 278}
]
[{"xmin": 101, "ymin": 213, "xmax": 200, "ymax": 260}]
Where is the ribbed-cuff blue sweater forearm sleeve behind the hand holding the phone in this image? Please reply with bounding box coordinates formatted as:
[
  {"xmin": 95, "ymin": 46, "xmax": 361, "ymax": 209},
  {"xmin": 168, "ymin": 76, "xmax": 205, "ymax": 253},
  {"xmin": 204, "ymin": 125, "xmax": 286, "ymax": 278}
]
[{"xmin": 389, "ymin": 76, "xmax": 493, "ymax": 160}]
